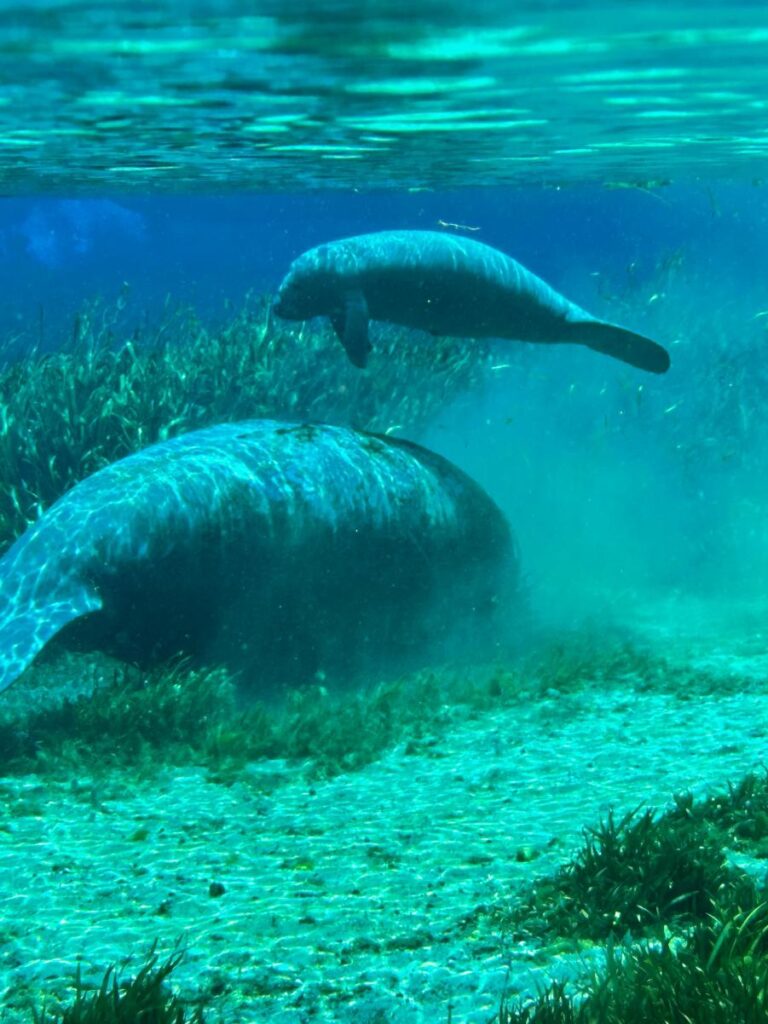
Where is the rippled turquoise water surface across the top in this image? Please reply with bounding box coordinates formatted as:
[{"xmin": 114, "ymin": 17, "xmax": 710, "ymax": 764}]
[{"xmin": 0, "ymin": 0, "xmax": 768, "ymax": 196}]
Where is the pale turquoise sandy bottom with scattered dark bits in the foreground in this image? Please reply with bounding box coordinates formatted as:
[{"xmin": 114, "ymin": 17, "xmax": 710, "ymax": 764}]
[{"xmin": 0, "ymin": 601, "xmax": 768, "ymax": 1024}]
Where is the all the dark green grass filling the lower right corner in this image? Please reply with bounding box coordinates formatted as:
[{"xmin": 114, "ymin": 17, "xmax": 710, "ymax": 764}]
[{"xmin": 500, "ymin": 774, "xmax": 768, "ymax": 1024}]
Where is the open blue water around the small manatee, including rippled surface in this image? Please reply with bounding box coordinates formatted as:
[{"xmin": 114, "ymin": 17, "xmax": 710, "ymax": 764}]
[{"xmin": 0, "ymin": 6, "xmax": 768, "ymax": 1020}]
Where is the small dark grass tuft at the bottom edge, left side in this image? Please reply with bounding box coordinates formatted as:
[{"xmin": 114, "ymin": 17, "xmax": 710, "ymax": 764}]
[{"xmin": 32, "ymin": 942, "xmax": 204, "ymax": 1024}]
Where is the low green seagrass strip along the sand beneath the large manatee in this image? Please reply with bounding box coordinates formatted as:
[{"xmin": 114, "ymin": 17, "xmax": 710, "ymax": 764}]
[{"xmin": 0, "ymin": 630, "xmax": 757, "ymax": 782}]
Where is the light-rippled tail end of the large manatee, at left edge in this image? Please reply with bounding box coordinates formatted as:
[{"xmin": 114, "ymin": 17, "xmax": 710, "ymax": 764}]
[{"xmin": 0, "ymin": 586, "xmax": 102, "ymax": 690}]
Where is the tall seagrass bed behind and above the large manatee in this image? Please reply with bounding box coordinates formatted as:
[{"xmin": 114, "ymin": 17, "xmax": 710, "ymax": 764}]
[{"xmin": 0, "ymin": 298, "xmax": 493, "ymax": 550}]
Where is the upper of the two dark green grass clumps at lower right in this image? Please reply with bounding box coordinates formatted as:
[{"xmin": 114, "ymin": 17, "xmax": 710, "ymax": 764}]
[{"xmin": 501, "ymin": 773, "xmax": 768, "ymax": 940}]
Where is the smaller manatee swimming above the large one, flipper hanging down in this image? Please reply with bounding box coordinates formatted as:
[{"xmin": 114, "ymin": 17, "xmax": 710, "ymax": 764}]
[{"xmin": 273, "ymin": 231, "xmax": 670, "ymax": 374}]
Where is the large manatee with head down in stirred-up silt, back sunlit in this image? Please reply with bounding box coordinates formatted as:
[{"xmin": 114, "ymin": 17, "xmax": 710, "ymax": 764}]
[{"xmin": 0, "ymin": 420, "xmax": 517, "ymax": 689}]
